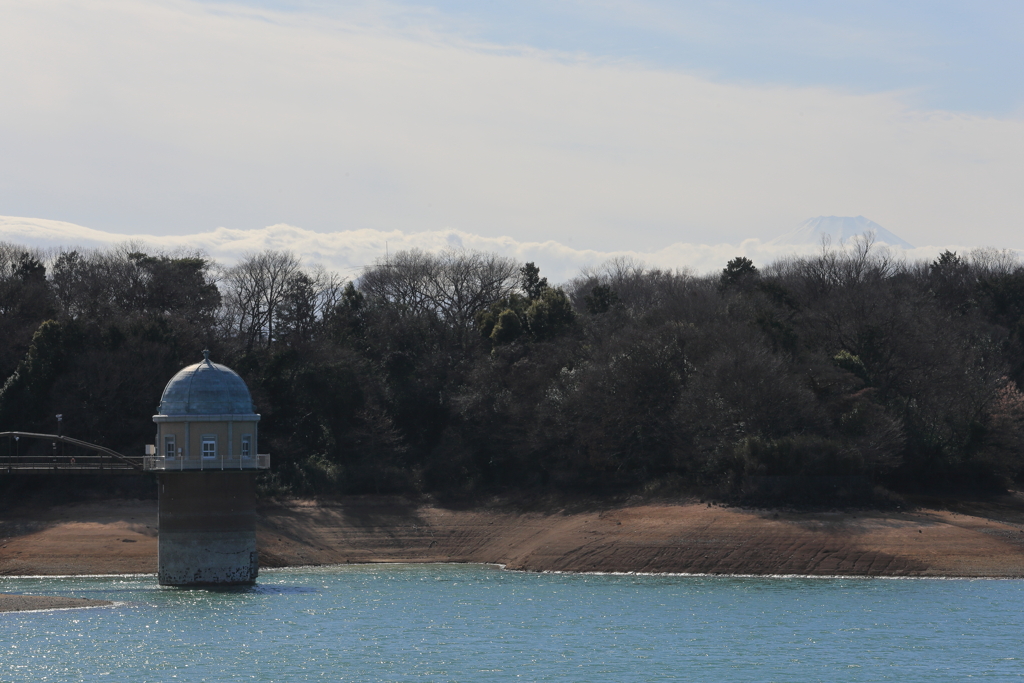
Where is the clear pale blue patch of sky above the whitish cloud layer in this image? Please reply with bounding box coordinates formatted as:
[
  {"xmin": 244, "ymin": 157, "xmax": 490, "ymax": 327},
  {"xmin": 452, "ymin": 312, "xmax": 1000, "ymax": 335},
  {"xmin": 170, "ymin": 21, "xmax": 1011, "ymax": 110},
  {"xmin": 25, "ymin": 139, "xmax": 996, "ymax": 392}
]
[{"xmin": 210, "ymin": 0, "xmax": 1024, "ymax": 115}]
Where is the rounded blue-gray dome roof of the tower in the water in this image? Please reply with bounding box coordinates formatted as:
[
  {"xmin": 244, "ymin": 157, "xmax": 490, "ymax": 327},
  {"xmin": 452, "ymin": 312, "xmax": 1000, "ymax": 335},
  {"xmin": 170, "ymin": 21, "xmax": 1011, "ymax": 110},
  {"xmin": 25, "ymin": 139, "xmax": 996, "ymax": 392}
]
[{"xmin": 160, "ymin": 357, "xmax": 255, "ymax": 415}]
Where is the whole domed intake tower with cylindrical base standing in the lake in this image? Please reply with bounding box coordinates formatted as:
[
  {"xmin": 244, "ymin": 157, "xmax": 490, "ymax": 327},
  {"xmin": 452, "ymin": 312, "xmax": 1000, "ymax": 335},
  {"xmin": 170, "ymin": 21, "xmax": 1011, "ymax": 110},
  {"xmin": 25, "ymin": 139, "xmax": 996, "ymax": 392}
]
[{"xmin": 143, "ymin": 351, "xmax": 270, "ymax": 586}]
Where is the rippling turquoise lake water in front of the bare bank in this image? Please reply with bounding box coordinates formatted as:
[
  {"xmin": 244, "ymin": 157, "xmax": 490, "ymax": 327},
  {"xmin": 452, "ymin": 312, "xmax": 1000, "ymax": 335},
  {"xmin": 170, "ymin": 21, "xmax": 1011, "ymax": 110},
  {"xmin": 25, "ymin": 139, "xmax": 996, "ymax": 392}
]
[{"xmin": 0, "ymin": 564, "xmax": 1024, "ymax": 682}]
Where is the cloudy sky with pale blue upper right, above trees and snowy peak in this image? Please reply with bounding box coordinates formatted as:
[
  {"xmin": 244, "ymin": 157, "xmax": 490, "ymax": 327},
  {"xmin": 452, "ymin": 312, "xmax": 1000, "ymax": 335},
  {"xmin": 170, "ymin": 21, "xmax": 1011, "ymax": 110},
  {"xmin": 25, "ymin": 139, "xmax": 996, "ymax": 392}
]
[{"xmin": 0, "ymin": 0, "xmax": 1024, "ymax": 278}]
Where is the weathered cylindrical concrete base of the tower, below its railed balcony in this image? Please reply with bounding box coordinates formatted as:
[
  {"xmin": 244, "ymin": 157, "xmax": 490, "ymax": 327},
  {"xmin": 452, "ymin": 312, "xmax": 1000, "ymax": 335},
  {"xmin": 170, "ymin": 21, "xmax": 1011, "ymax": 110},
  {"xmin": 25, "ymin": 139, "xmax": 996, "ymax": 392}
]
[{"xmin": 158, "ymin": 470, "xmax": 259, "ymax": 586}]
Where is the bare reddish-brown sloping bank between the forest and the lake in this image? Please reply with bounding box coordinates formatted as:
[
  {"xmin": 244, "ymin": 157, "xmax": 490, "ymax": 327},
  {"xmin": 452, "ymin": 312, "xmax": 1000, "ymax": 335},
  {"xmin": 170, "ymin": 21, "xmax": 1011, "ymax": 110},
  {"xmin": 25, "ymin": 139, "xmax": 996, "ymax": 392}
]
[{"xmin": 0, "ymin": 496, "xmax": 1024, "ymax": 610}]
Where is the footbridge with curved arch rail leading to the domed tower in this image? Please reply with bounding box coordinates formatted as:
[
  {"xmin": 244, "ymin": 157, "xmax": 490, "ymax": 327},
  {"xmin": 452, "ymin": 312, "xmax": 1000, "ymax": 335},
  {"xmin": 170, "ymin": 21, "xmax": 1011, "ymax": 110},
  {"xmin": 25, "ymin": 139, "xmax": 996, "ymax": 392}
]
[{"xmin": 0, "ymin": 431, "xmax": 142, "ymax": 474}]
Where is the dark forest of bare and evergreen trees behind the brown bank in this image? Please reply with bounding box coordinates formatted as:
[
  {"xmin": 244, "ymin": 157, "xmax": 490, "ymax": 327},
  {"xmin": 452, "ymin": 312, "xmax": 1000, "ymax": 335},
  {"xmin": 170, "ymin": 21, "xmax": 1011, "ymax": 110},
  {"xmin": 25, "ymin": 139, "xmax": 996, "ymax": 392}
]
[{"xmin": 0, "ymin": 237, "xmax": 1024, "ymax": 505}]
